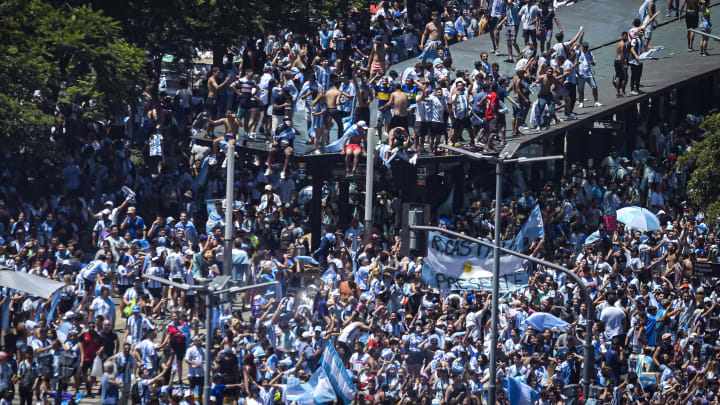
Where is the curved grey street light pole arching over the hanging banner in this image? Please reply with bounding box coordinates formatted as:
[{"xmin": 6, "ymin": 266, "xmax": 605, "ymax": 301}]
[{"xmin": 410, "ymin": 225, "xmax": 595, "ymax": 402}]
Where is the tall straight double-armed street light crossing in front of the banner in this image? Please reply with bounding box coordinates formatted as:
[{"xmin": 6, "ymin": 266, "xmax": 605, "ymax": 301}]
[{"xmin": 440, "ymin": 145, "xmax": 564, "ymax": 405}]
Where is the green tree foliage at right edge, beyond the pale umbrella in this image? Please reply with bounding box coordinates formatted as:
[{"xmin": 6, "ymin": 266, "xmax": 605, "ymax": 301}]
[{"xmin": 678, "ymin": 114, "xmax": 720, "ymax": 225}]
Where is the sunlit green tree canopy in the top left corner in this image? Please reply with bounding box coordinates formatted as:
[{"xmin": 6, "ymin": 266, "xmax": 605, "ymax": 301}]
[{"xmin": 0, "ymin": 0, "xmax": 145, "ymax": 154}]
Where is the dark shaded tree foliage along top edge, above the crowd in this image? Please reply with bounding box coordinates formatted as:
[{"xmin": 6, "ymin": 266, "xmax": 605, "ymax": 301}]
[{"xmin": 57, "ymin": 0, "xmax": 369, "ymax": 67}]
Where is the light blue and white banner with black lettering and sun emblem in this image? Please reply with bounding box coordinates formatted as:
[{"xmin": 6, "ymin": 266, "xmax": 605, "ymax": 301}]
[{"xmin": 422, "ymin": 232, "xmax": 528, "ymax": 294}]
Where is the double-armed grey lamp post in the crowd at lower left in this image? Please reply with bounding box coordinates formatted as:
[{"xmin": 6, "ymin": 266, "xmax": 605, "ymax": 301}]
[{"xmin": 143, "ymin": 275, "xmax": 278, "ymax": 404}]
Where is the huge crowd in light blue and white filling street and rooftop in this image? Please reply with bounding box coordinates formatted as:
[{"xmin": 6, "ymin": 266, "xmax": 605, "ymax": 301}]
[{"xmin": 0, "ymin": 0, "xmax": 720, "ymax": 405}]
